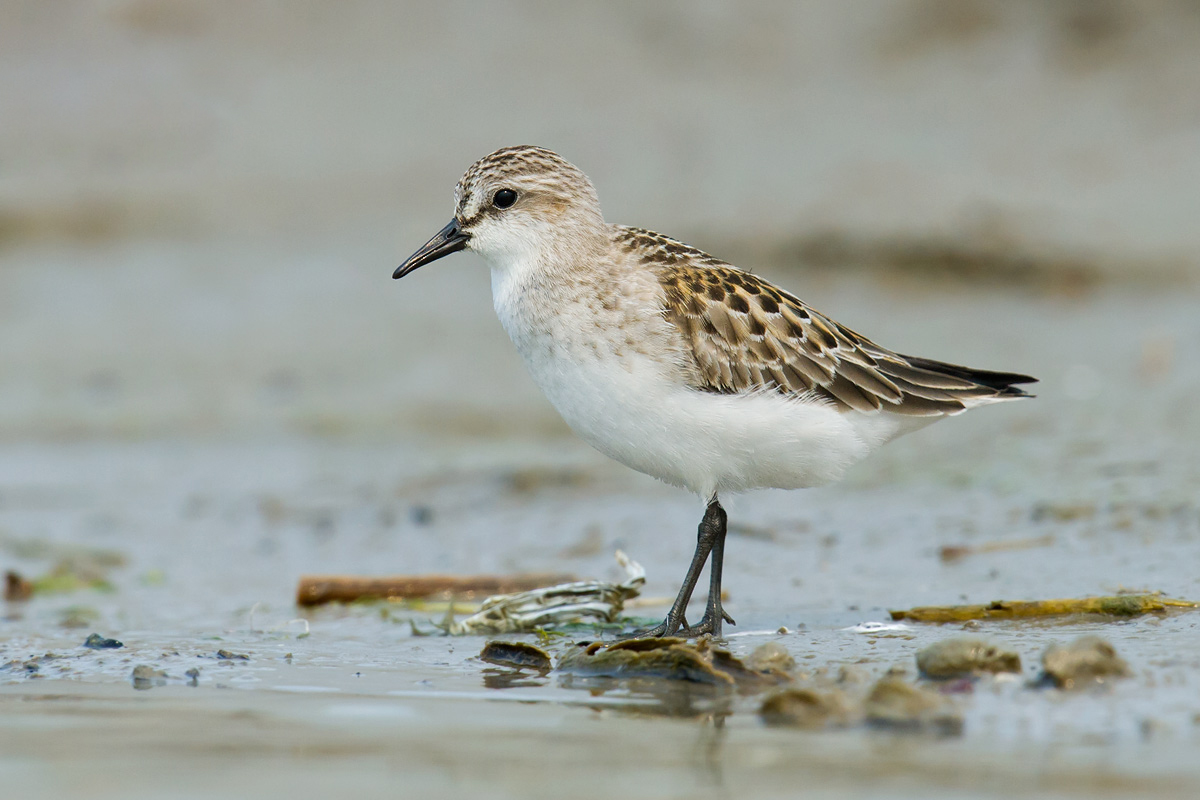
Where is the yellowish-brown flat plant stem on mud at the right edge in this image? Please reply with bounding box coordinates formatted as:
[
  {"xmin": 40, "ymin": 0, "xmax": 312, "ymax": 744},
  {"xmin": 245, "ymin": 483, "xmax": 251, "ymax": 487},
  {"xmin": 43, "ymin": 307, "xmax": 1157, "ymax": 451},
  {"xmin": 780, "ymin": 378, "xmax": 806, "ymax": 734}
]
[{"xmin": 889, "ymin": 594, "xmax": 1200, "ymax": 622}]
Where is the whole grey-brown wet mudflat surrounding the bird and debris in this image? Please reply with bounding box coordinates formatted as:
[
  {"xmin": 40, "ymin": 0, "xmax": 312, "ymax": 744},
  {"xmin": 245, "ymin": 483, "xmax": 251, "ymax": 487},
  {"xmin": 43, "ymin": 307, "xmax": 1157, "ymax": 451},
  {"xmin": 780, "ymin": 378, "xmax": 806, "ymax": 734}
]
[{"xmin": 7, "ymin": 0, "xmax": 1200, "ymax": 799}]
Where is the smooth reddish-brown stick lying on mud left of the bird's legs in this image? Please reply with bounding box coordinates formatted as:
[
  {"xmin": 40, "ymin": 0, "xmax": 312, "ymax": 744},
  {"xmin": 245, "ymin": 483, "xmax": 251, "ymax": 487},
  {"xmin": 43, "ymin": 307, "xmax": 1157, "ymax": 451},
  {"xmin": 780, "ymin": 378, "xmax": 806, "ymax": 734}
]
[{"xmin": 296, "ymin": 572, "xmax": 575, "ymax": 606}]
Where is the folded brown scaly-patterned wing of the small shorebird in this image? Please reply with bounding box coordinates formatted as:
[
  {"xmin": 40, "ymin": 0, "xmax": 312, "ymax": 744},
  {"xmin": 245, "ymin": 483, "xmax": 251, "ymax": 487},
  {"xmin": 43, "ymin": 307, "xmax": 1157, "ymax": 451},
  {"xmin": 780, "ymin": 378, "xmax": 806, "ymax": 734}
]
[{"xmin": 652, "ymin": 261, "xmax": 1034, "ymax": 416}]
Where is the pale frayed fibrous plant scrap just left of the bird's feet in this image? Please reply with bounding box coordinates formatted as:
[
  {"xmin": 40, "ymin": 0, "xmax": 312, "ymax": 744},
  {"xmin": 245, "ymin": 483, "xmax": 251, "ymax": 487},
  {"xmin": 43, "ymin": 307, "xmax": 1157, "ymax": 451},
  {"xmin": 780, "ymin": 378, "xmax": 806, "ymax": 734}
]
[{"xmin": 445, "ymin": 551, "xmax": 646, "ymax": 636}]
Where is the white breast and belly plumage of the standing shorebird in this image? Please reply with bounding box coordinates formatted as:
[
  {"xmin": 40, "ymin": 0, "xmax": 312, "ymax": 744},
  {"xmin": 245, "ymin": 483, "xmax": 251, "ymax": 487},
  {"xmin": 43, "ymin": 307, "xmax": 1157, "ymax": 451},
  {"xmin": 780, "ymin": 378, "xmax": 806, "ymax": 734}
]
[{"xmin": 493, "ymin": 266, "xmax": 900, "ymax": 498}]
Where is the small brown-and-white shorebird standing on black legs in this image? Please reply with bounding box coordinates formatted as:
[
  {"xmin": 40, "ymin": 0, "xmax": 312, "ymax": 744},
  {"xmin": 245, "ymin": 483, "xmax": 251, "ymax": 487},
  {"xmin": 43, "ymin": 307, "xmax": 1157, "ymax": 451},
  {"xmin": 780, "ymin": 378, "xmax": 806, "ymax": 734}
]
[{"xmin": 392, "ymin": 145, "xmax": 1036, "ymax": 638}]
